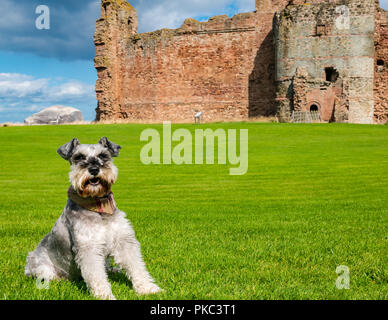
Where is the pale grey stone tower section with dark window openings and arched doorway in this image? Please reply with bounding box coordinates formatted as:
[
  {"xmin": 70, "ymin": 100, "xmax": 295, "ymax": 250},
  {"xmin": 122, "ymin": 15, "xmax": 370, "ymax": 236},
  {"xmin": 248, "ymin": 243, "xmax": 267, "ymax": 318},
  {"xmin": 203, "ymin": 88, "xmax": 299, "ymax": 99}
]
[{"xmin": 274, "ymin": 0, "xmax": 375, "ymax": 123}]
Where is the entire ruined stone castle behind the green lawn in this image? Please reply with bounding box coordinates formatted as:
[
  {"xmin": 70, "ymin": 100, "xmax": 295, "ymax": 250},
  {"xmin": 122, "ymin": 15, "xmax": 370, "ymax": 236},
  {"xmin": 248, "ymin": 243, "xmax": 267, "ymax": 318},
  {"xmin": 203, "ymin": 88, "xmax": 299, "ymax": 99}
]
[{"xmin": 94, "ymin": 0, "xmax": 388, "ymax": 123}]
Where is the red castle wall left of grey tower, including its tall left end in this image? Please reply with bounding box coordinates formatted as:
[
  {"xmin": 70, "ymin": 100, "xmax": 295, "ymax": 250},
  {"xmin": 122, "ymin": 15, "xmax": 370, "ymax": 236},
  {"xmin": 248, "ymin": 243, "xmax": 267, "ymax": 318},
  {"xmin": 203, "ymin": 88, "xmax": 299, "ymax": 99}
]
[{"xmin": 95, "ymin": 0, "xmax": 288, "ymax": 122}]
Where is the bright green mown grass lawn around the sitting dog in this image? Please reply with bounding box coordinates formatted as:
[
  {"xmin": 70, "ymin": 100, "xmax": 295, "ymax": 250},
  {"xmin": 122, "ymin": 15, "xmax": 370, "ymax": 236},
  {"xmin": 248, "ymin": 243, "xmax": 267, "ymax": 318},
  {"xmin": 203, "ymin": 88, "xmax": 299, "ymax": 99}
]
[{"xmin": 0, "ymin": 123, "xmax": 388, "ymax": 299}]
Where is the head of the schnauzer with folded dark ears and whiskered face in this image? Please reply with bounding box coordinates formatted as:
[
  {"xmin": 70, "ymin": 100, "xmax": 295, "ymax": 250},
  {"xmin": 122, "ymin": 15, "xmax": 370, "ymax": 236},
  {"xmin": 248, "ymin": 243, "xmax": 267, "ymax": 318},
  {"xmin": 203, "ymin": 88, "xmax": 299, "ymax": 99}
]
[{"xmin": 57, "ymin": 138, "xmax": 121, "ymax": 198}]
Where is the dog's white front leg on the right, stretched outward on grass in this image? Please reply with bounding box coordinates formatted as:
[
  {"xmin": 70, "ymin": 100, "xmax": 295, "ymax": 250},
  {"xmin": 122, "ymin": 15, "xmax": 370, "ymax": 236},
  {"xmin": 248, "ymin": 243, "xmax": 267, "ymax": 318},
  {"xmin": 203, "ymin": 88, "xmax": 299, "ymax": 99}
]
[{"xmin": 113, "ymin": 236, "xmax": 161, "ymax": 294}]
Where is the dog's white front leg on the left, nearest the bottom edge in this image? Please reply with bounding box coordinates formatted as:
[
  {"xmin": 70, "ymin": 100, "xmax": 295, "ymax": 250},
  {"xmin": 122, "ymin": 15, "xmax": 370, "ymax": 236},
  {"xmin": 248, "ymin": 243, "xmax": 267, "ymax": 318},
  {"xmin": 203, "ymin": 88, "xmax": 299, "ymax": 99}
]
[{"xmin": 76, "ymin": 247, "xmax": 116, "ymax": 300}]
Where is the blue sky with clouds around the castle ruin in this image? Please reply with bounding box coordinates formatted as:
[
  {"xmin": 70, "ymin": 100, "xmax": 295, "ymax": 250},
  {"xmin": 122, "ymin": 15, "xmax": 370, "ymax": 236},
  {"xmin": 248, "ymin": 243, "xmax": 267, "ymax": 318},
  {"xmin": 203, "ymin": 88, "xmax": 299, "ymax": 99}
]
[{"xmin": 0, "ymin": 0, "xmax": 388, "ymax": 123}]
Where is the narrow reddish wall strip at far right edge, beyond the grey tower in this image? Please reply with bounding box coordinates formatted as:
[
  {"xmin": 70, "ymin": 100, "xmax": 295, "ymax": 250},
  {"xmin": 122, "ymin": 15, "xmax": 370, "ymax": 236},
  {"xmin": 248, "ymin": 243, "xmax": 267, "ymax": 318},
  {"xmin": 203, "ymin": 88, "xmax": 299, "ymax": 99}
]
[{"xmin": 374, "ymin": 1, "xmax": 388, "ymax": 123}]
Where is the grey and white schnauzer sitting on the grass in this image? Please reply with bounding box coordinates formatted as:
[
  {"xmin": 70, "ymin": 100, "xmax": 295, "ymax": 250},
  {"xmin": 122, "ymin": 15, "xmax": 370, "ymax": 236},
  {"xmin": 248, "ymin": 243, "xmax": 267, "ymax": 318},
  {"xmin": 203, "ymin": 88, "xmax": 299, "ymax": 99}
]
[{"xmin": 25, "ymin": 138, "xmax": 160, "ymax": 299}]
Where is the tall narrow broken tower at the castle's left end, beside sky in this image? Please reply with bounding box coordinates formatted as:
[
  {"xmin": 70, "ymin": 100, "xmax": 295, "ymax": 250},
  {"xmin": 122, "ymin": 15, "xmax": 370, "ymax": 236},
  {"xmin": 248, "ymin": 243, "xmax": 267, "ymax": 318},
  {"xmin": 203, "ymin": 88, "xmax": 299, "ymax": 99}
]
[{"xmin": 94, "ymin": 0, "xmax": 138, "ymax": 120}]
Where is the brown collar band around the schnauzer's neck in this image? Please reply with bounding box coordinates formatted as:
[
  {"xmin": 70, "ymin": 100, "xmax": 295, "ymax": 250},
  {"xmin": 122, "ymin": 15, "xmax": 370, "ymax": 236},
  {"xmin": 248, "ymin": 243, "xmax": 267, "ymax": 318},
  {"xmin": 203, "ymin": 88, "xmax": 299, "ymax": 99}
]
[{"xmin": 67, "ymin": 186, "xmax": 116, "ymax": 215}]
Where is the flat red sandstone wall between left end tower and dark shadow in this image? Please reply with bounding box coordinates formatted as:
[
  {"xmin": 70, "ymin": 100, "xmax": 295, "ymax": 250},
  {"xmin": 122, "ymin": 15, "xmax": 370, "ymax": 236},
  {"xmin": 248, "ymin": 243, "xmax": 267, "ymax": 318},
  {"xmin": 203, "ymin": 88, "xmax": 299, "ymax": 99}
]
[{"xmin": 121, "ymin": 13, "xmax": 257, "ymax": 121}]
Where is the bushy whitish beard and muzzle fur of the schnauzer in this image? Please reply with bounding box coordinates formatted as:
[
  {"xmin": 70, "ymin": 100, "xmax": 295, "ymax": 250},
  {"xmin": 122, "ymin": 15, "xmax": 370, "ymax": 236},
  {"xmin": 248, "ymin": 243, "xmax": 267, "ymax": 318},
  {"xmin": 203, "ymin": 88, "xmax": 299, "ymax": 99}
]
[{"xmin": 70, "ymin": 166, "xmax": 117, "ymax": 198}]
